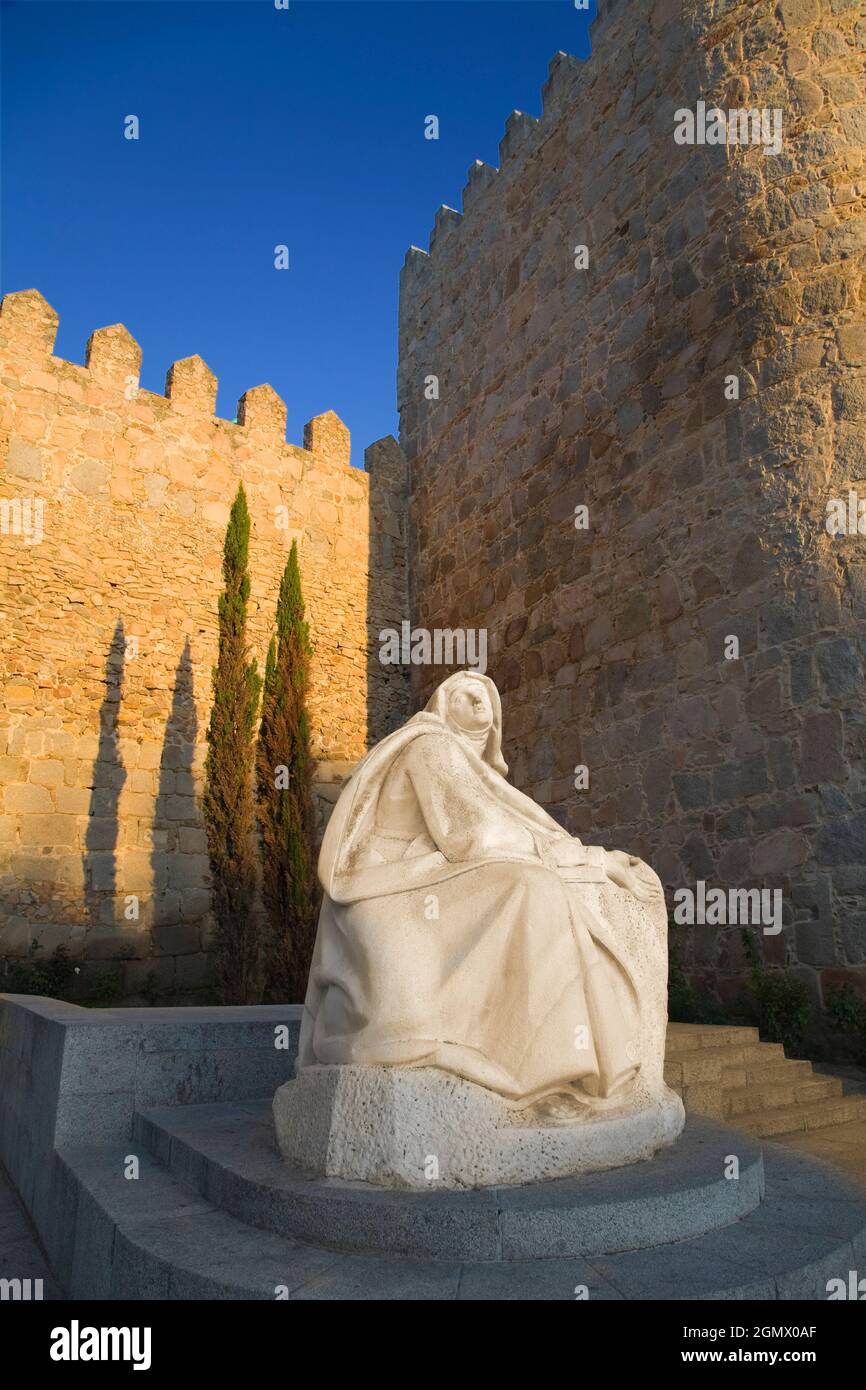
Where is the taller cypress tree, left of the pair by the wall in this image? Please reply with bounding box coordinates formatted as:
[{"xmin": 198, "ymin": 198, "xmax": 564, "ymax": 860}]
[{"xmin": 203, "ymin": 484, "xmax": 261, "ymax": 1004}]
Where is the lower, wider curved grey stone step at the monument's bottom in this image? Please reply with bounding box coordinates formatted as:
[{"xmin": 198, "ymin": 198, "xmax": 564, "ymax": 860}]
[{"xmin": 61, "ymin": 1131, "xmax": 866, "ymax": 1301}]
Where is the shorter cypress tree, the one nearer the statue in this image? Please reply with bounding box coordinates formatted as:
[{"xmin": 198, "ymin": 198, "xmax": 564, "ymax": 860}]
[{"xmin": 256, "ymin": 541, "xmax": 318, "ymax": 1004}]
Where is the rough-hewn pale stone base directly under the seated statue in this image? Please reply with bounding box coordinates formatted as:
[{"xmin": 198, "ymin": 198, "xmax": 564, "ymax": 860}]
[{"xmin": 274, "ymin": 1066, "xmax": 685, "ymax": 1191}]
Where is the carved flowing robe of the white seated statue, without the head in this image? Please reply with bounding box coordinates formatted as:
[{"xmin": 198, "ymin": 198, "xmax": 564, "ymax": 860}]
[{"xmin": 299, "ymin": 713, "xmax": 639, "ymax": 1104}]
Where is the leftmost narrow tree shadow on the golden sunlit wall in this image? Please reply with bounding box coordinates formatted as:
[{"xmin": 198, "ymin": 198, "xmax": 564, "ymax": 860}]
[{"xmin": 83, "ymin": 619, "xmax": 126, "ymax": 926}]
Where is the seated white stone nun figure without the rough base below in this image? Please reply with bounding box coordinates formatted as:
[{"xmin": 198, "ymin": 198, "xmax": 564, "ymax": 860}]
[{"xmin": 275, "ymin": 671, "xmax": 681, "ymax": 1180}]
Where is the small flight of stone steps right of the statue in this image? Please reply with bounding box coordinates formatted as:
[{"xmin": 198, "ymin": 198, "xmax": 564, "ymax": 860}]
[{"xmin": 664, "ymin": 1023, "xmax": 866, "ymax": 1136}]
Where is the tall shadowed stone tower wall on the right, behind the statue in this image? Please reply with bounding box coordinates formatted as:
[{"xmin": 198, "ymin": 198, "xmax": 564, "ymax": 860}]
[{"xmin": 399, "ymin": 0, "xmax": 866, "ymax": 1023}]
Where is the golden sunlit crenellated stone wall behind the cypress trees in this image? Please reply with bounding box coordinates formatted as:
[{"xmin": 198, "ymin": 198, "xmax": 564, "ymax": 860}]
[{"xmin": 0, "ymin": 291, "xmax": 406, "ymax": 998}]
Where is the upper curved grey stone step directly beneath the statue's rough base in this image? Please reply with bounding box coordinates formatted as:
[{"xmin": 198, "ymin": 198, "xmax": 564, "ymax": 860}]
[{"xmin": 135, "ymin": 1102, "xmax": 763, "ymax": 1259}]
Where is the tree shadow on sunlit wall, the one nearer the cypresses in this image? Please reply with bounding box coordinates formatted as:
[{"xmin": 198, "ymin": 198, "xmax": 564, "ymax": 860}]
[{"xmin": 150, "ymin": 638, "xmax": 203, "ymax": 954}]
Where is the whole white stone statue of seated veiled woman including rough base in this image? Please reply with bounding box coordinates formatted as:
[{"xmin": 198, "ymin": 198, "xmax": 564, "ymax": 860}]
[{"xmin": 274, "ymin": 671, "xmax": 684, "ymax": 1187}]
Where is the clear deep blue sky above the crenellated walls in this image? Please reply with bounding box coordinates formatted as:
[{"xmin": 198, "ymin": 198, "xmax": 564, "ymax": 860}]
[{"xmin": 0, "ymin": 0, "xmax": 595, "ymax": 464}]
